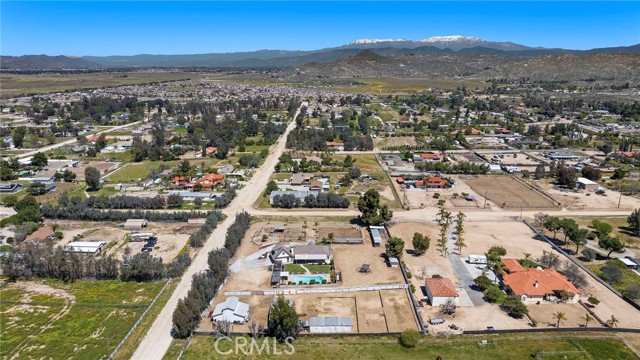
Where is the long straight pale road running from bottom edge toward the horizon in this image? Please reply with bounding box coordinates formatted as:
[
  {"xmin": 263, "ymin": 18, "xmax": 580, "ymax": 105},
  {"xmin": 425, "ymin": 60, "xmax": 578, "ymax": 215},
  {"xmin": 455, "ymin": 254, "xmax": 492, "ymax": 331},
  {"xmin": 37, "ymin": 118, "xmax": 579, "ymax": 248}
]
[{"xmin": 132, "ymin": 103, "xmax": 307, "ymax": 359}]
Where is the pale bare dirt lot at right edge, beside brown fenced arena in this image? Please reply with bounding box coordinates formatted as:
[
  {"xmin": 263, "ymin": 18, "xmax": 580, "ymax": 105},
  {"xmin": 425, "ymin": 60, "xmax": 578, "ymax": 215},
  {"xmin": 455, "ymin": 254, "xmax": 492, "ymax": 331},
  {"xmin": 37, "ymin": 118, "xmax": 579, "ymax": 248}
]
[{"xmin": 533, "ymin": 180, "xmax": 640, "ymax": 210}]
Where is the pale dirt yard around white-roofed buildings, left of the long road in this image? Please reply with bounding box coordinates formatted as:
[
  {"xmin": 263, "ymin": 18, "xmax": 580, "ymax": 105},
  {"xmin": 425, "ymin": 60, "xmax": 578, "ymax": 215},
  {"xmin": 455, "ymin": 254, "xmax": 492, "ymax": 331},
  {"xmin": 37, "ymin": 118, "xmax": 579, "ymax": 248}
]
[{"xmin": 49, "ymin": 220, "xmax": 189, "ymax": 263}]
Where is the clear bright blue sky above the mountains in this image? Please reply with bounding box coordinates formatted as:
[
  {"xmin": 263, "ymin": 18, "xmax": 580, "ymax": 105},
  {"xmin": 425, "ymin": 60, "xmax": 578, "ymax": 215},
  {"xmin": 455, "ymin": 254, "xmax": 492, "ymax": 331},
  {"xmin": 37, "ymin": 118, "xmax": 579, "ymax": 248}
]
[{"xmin": 0, "ymin": 0, "xmax": 640, "ymax": 56}]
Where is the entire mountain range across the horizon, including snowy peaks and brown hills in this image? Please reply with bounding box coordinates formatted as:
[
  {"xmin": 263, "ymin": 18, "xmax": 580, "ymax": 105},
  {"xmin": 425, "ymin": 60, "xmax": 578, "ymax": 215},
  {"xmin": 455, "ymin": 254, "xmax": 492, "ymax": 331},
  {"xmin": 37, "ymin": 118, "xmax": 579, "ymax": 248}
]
[{"xmin": 0, "ymin": 36, "xmax": 640, "ymax": 82}]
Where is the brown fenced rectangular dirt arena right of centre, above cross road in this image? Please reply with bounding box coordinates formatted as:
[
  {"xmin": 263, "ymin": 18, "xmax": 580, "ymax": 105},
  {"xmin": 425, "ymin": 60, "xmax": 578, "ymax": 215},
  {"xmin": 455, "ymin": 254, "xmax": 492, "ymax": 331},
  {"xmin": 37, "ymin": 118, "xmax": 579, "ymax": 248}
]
[{"xmin": 460, "ymin": 176, "xmax": 555, "ymax": 209}]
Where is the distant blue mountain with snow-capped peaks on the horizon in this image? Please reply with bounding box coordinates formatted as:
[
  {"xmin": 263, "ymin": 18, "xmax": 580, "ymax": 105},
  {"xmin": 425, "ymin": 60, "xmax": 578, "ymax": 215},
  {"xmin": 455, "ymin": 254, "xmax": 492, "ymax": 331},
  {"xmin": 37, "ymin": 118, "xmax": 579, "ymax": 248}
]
[{"xmin": 340, "ymin": 35, "xmax": 531, "ymax": 51}]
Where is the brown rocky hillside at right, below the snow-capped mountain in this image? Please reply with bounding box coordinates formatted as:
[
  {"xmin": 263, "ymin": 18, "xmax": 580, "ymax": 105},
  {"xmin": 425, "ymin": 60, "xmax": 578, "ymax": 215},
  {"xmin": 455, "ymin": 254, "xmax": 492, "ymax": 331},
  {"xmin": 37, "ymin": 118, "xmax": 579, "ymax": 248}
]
[{"xmin": 290, "ymin": 50, "xmax": 640, "ymax": 84}]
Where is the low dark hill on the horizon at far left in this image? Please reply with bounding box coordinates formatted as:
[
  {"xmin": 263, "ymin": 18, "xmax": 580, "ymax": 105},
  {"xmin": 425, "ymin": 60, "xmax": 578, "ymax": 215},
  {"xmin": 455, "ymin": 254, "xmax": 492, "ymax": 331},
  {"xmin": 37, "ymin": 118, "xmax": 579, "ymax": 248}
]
[{"xmin": 0, "ymin": 55, "xmax": 103, "ymax": 70}]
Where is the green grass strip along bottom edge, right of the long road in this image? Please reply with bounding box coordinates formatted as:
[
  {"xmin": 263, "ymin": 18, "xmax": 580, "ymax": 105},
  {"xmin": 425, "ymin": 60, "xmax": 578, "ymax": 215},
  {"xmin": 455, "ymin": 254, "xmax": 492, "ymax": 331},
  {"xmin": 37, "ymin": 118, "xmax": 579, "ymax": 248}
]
[{"xmin": 176, "ymin": 334, "xmax": 637, "ymax": 360}]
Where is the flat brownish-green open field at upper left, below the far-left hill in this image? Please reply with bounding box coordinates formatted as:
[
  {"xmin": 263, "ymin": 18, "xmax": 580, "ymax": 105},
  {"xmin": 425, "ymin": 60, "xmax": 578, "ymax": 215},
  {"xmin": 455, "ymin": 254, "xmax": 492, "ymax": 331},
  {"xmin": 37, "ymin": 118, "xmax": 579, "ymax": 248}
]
[{"xmin": 0, "ymin": 72, "xmax": 200, "ymax": 98}]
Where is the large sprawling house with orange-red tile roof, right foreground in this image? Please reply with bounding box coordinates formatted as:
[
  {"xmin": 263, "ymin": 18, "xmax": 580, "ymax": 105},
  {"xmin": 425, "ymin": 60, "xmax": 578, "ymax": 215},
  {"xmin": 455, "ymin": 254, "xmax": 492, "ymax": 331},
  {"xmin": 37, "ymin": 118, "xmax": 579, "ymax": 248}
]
[{"xmin": 502, "ymin": 259, "xmax": 581, "ymax": 303}]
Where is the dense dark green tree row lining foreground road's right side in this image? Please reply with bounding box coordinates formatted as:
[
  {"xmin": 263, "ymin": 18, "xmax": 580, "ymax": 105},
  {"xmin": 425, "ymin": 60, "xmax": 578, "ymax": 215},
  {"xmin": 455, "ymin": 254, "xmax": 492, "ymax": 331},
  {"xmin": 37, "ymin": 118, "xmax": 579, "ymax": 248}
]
[{"xmin": 171, "ymin": 212, "xmax": 251, "ymax": 338}]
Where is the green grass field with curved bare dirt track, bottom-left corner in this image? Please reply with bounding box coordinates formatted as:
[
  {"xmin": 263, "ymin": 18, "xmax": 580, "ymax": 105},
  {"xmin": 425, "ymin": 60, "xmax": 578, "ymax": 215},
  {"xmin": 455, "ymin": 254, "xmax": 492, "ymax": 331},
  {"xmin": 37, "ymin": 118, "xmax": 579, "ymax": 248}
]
[{"xmin": 0, "ymin": 280, "xmax": 164, "ymax": 359}]
